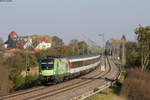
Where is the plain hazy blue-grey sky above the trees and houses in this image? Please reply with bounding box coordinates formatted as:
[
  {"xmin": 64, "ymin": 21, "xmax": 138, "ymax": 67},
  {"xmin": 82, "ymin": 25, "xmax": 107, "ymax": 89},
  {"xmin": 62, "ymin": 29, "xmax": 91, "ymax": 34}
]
[{"xmin": 0, "ymin": 0, "xmax": 150, "ymax": 43}]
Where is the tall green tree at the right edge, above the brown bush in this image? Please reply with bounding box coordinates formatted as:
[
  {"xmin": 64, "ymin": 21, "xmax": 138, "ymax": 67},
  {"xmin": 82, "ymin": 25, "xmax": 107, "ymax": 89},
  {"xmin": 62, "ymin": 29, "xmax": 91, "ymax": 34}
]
[{"xmin": 135, "ymin": 26, "xmax": 150, "ymax": 70}]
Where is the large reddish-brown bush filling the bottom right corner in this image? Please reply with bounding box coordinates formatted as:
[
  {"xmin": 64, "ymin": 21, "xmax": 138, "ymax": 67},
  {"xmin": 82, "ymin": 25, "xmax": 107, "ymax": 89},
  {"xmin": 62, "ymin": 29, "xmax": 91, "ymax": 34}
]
[{"xmin": 122, "ymin": 69, "xmax": 150, "ymax": 100}]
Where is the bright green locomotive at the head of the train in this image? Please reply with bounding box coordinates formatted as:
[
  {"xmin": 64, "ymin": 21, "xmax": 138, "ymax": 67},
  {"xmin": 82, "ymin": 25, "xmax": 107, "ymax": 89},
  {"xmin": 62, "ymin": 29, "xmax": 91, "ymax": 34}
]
[{"xmin": 39, "ymin": 57, "xmax": 69, "ymax": 84}]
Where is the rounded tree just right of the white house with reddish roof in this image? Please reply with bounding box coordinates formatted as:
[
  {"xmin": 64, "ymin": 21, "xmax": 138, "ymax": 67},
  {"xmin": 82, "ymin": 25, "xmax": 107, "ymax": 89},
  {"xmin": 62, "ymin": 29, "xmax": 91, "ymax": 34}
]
[{"xmin": 52, "ymin": 36, "xmax": 64, "ymax": 47}]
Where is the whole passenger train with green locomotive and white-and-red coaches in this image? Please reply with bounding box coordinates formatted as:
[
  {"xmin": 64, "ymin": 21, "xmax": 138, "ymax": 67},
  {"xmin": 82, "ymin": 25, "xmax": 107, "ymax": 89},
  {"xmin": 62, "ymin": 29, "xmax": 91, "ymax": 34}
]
[{"xmin": 39, "ymin": 54, "xmax": 101, "ymax": 84}]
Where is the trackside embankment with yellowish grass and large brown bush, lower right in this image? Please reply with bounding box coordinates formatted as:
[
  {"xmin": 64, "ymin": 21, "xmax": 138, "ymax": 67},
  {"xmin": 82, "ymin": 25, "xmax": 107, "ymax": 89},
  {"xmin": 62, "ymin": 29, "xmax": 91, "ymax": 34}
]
[{"xmin": 87, "ymin": 60, "xmax": 150, "ymax": 100}]
